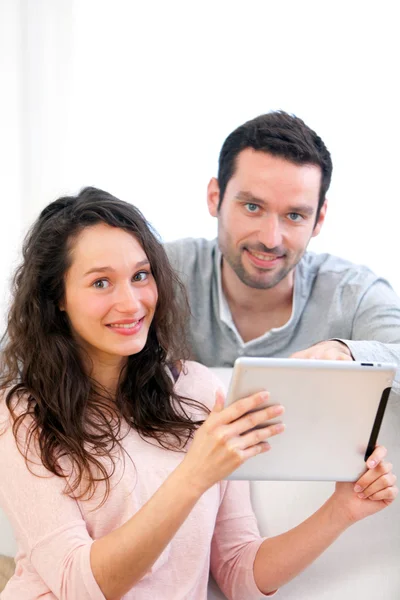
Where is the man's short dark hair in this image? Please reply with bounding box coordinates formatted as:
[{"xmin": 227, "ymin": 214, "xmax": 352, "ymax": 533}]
[{"xmin": 218, "ymin": 110, "xmax": 332, "ymax": 218}]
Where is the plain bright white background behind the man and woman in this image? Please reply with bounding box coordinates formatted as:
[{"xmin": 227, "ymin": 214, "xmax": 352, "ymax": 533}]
[{"xmin": 0, "ymin": 0, "xmax": 400, "ymax": 600}]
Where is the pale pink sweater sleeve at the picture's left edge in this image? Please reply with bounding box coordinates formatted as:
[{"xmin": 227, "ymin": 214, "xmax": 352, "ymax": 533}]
[{"xmin": 0, "ymin": 408, "xmax": 105, "ymax": 600}]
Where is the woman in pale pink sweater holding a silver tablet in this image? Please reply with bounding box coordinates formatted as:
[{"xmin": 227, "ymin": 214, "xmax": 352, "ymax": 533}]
[{"xmin": 0, "ymin": 188, "xmax": 397, "ymax": 600}]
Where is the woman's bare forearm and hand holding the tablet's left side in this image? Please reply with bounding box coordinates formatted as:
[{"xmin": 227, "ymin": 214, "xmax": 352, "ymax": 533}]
[{"xmin": 90, "ymin": 394, "xmax": 282, "ymax": 600}]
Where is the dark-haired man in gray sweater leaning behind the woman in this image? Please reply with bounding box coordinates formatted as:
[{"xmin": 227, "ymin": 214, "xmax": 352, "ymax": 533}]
[{"xmin": 166, "ymin": 111, "xmax": 400, "ymax": 382}]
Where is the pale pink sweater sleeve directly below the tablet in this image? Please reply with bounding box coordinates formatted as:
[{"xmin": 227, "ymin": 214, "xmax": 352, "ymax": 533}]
[{"xmin": 211, "ymin": 481, "xmax": 275, "ymax": 600}]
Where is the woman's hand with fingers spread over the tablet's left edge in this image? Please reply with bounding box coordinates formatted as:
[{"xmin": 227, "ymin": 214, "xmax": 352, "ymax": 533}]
[{"xmin": 181, "ymin": 391, "xmax": 284, "ymax": 493}]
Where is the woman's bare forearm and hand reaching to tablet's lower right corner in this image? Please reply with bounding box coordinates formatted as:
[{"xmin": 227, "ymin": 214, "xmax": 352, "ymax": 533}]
[{"xmin": 254, "ymin": 446, "xmax": 398, "ymax": 593}]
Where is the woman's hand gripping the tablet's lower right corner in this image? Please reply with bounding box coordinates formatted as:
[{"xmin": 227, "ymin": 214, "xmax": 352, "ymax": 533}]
[{"xmin": 332, "ymin": 446, "xmax": 399, "ymax": 523}]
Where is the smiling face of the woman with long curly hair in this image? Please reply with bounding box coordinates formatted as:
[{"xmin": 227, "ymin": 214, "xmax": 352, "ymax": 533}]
[{"xmin": 61, "ymin": 223, "xmax": 158, "ymax": 366}]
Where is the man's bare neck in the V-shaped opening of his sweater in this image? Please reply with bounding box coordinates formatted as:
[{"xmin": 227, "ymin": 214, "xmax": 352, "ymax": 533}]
[{"xmin": 221, "ymin": 260, "xmax": 294, "ymax": 342}]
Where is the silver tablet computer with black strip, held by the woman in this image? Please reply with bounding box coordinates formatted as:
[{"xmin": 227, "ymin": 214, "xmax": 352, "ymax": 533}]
[{"xmin": 226, "ymin": 357, "xmax": 396, "ymax": 481}]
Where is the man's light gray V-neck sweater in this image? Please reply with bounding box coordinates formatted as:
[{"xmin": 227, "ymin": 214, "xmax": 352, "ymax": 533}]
[{"xmin": 165, "ymin": 238, "xmax": 400, "ymax": 390}]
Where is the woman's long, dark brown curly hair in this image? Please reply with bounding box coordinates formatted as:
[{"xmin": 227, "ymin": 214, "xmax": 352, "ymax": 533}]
[{"xmin": 0, "ymin": 188, "xmax": 204, "ymax": 498}]
